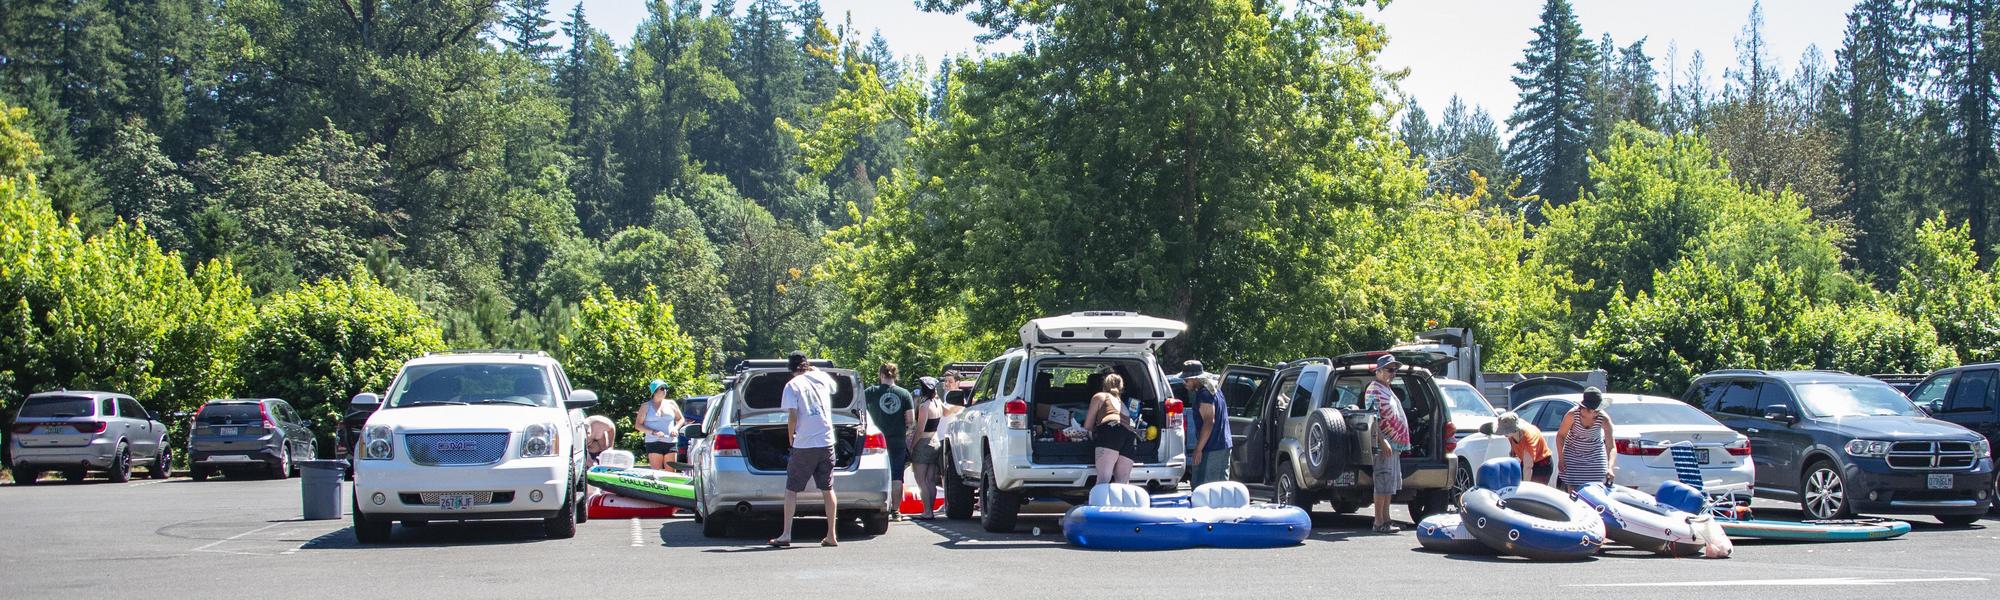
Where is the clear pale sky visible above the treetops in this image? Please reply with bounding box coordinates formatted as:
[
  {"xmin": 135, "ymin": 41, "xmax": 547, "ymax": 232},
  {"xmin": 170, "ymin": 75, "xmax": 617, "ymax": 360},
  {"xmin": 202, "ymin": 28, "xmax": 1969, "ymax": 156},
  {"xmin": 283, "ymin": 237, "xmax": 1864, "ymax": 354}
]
[{"xmin": 568, "ymin": 0, "xmax": 1854, "ymax": 120}]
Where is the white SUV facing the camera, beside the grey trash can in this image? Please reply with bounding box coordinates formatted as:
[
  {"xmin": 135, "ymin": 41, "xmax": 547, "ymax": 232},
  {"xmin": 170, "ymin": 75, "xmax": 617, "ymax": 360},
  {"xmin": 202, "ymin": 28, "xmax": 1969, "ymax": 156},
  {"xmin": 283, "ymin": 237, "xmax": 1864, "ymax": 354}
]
[{"xmin": 352, "ymin": 352, "xmax": 598, "ymax": 544}]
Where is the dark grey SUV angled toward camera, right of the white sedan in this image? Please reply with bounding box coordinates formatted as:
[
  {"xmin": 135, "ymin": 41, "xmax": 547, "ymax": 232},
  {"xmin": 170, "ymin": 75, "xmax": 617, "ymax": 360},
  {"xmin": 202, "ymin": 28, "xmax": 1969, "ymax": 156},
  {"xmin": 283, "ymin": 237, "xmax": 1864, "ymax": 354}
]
[{"xmin": 1680, "ymin": 370, "xmax": 1994, "ymax": 524}]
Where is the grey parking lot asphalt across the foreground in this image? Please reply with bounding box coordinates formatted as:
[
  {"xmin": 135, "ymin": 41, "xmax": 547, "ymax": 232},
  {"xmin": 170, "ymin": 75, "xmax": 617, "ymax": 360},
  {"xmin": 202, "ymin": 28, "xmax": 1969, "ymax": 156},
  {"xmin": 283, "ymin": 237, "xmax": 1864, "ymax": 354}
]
[{"xmin": 0, "ymin": 478, "xmax": 2000, "ymax": 598}]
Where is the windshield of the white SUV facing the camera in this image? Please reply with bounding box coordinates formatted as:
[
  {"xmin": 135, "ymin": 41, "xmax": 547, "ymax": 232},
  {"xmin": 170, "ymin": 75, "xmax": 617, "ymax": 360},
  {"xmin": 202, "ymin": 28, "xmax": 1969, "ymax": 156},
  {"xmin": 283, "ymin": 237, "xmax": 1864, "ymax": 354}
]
[{"xmin": 382, "ymin": 364, "xmax": 556, "ymax": 408}]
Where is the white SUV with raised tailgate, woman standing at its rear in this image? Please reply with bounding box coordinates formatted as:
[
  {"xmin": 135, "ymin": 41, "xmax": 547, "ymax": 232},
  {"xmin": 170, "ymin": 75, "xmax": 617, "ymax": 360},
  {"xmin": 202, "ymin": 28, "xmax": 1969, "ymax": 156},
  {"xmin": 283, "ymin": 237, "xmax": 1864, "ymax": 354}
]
[{"xmin": 940, "ymin": 312, "xmax": 1188, "ymax": 532}]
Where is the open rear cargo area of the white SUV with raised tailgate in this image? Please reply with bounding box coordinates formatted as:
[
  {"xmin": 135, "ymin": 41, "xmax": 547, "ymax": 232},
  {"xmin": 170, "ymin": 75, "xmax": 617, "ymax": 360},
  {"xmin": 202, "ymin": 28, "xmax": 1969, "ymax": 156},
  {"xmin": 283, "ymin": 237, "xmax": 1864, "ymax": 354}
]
[{"xmin": 1028, "ymin": 356, "xmax": 1166, "ymax": 464}]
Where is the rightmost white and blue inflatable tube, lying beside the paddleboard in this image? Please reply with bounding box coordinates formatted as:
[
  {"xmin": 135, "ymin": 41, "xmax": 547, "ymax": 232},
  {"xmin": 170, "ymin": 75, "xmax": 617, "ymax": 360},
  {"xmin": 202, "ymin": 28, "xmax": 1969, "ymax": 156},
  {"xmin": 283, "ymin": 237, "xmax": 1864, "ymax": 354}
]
[{"xmin": 1576, "ymin": 482, "xmax": 1714, "ymax": 556}]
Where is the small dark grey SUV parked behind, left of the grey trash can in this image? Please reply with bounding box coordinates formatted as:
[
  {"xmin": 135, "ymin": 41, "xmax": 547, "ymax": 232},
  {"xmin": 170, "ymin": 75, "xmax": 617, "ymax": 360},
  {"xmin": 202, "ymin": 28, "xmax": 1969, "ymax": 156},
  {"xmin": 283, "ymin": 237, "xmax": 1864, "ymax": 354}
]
[{"xmin": 188, "ymin": 398, "xmax": 318, "ymax": 480}]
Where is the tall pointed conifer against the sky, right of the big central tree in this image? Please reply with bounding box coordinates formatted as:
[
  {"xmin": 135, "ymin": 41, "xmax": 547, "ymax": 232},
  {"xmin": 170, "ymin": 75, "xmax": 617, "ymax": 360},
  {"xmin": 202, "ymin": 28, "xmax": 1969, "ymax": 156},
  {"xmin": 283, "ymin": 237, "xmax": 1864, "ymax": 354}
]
[{"xmin": 1506, "ymin": 0, "xmax": 1596, "ymax": 218}]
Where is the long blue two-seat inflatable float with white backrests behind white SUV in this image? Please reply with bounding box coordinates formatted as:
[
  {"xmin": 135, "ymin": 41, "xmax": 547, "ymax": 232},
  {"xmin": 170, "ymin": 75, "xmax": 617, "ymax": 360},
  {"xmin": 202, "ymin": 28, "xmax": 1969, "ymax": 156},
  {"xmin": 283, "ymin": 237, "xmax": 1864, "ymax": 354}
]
[{"xmin": 1062, "ymin": 482, "xmax": 1312, "ymax": 550}]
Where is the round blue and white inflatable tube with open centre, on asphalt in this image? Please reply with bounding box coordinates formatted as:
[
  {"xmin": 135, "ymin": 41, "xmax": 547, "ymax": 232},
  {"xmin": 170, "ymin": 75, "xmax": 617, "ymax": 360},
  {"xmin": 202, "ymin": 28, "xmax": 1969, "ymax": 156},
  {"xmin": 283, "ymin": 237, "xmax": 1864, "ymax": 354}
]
[{"xmin": 1460, "ymin": 458, "xmax": 1604, "ymax": 560}]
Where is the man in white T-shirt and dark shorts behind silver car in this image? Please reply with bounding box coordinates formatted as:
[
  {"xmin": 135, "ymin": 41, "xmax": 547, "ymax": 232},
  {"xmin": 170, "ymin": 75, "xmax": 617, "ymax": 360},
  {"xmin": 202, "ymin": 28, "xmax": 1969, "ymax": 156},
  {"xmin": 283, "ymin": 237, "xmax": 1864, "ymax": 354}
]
[{"xmin": 770, "ymin": 352, "xmax": 840, "ymax": 548}]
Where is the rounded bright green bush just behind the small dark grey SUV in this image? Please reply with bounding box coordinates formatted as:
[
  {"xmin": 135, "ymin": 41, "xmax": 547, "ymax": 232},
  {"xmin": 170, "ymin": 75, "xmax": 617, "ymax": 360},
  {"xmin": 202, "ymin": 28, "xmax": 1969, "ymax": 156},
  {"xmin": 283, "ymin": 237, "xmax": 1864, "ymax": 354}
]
[{"xmin": 236, "ymin": 266, "xmax": 444, "ymax": 440}]
